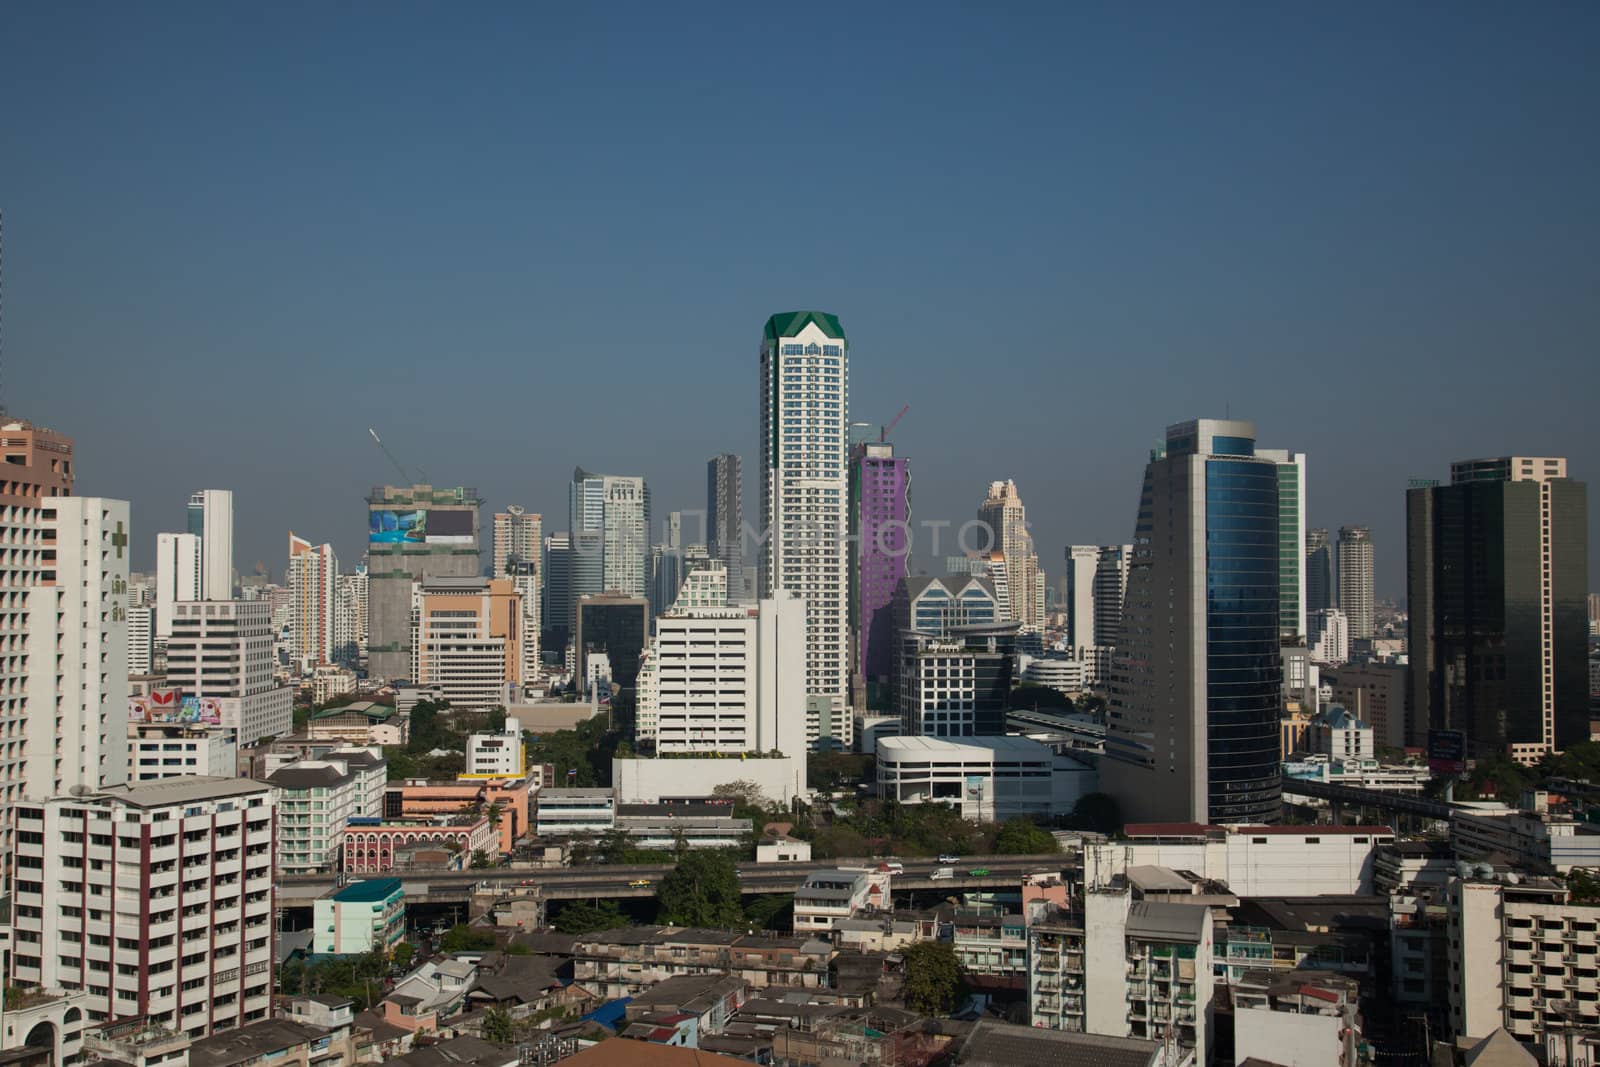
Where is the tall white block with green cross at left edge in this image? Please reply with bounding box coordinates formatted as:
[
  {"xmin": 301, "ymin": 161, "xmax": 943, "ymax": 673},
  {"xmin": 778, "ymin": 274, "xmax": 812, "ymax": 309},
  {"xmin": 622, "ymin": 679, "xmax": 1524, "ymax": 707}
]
[{"xmin": 22, "ymin": 496, "xmax": 128, "ymax": 798}]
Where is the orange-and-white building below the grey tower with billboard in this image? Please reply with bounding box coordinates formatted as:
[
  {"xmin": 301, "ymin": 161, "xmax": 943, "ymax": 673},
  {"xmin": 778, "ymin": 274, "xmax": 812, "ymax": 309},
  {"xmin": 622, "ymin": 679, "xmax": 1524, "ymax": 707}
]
[{"xmin": 411, "ymin": 577, "xmax": 523, "ymax": 710}]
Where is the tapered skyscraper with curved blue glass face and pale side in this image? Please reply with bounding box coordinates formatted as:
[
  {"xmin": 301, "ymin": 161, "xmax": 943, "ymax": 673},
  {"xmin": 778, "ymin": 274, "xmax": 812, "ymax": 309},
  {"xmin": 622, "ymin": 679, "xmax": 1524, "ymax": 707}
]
[{"xmin": 1101, "ymin": 419, "xmax": 1283, "ymax": 822}]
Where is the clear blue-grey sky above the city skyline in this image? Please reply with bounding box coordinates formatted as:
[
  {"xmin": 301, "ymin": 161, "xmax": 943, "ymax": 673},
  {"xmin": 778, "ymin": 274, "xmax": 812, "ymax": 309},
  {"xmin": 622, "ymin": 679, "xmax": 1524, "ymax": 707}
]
[{"xmin": 0, "ymin": 3, "xmax": 1600, "ymax": 595}]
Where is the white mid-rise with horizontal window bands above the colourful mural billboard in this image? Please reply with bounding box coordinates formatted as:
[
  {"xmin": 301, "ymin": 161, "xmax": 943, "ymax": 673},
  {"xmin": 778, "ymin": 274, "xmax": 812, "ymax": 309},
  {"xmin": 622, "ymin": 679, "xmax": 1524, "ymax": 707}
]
[{"xmin": 166, "ymin": 600, "xmax": 294, "ymax": 745}]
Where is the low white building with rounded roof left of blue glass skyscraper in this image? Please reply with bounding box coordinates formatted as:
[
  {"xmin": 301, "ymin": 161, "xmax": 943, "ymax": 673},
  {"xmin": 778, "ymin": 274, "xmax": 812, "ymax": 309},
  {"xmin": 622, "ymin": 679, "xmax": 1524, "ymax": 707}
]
[{"xmin": 877, "ymin": 737, "xmax": 1096, "ymax": 822}]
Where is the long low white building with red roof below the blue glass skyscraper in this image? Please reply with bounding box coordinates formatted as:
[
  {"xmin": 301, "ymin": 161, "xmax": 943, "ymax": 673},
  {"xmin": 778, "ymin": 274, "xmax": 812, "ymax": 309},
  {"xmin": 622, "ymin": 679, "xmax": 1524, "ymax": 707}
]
[{"xmin": 1107, "ymin": 822, "xmax": 1395, "ymax": 896}]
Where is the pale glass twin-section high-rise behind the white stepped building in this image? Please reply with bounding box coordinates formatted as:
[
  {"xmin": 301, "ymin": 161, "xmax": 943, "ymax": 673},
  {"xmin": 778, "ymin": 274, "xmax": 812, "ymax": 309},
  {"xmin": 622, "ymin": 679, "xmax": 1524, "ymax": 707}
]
[{"xmin": 566, "ymin": 467, "xmax": 650, "ymax": 601}]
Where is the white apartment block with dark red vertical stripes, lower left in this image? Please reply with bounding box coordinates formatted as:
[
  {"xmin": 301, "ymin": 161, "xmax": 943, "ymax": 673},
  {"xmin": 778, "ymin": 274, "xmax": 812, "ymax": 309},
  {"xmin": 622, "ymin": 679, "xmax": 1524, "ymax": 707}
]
[{"xmin": 13, "ymin": 777, "xmax": 274, "ymax": 1037}]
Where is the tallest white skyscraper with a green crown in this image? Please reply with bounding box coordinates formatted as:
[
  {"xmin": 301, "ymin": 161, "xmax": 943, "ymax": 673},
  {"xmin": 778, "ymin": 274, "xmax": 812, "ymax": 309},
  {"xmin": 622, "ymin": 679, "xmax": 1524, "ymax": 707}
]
[{"xmin": 760, "ymin": 312, "xmax": 854, "ymax": 749}]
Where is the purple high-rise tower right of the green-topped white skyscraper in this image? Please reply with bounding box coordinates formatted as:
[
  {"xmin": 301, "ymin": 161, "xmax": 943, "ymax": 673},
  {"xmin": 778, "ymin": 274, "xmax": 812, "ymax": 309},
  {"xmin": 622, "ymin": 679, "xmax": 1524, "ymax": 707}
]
[{"xmin": 850, "ymin": 442, "xmax": 910, "ymax": 694}]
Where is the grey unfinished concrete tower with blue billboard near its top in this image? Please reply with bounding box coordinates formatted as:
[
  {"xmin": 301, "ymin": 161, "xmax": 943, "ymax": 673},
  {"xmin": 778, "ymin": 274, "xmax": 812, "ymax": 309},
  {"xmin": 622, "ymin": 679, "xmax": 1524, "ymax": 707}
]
[{"xmin": 366, "ymin": 485, "xmax": 480, "ymax": 681}]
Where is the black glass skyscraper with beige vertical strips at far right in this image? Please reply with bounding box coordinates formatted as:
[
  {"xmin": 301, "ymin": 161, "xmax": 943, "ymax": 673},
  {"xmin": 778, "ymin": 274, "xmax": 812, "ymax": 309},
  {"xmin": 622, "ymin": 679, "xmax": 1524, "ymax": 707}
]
[{"xmin": 1414, "ymin": 456, "xmax": 1589, "ymax": 763}]
